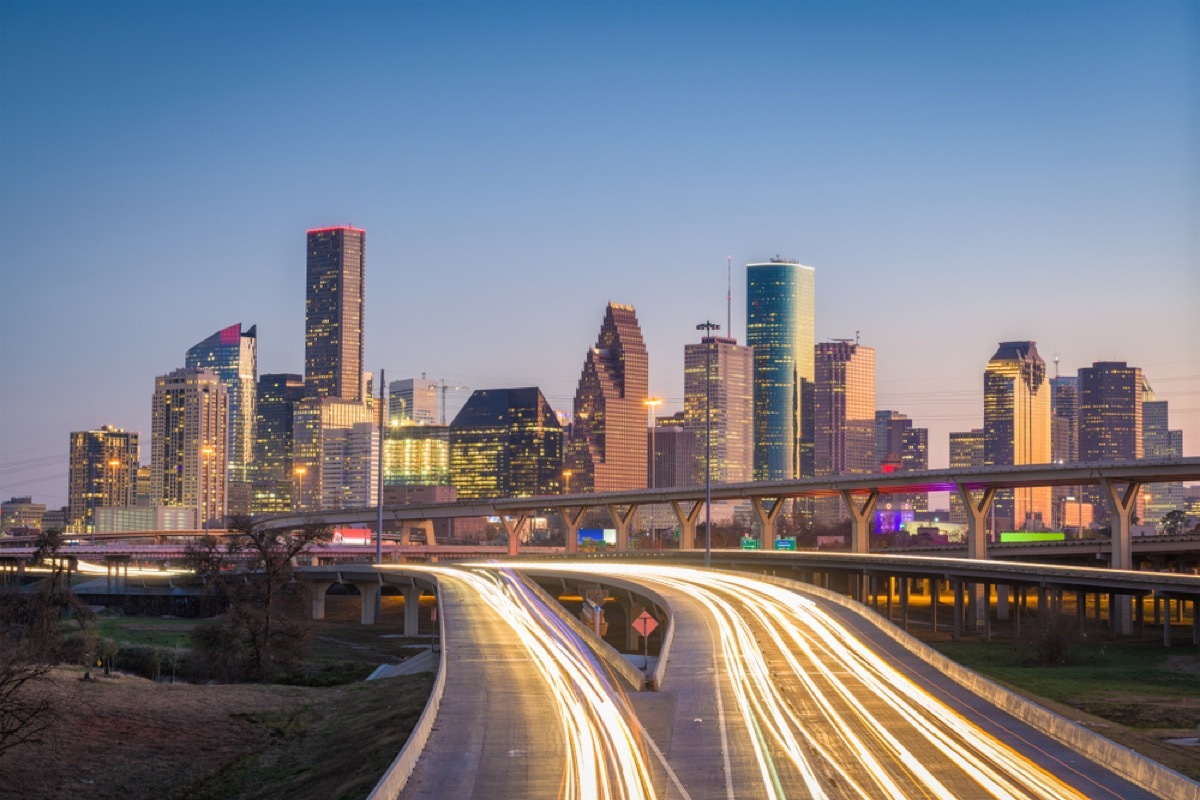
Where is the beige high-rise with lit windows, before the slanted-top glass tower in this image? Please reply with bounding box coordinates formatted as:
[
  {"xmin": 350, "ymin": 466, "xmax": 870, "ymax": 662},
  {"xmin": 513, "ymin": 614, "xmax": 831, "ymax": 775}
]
[{"xmin": 150, "ymin": 367, "xmax": 229, "ymax": 528}]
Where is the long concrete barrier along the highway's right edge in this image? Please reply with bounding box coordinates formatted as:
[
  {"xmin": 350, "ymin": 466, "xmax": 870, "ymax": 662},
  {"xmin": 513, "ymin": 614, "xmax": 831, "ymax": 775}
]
[{"xmin": 758, "ymin": 572, "xmax": 1200, "ymax": 800}]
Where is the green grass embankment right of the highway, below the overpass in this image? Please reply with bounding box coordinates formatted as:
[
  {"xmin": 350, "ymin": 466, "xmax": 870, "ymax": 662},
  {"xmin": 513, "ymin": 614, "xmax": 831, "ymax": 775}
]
[{"xmin": 923, "ymin": 637, "xmax": 1200, "ymax": 780}]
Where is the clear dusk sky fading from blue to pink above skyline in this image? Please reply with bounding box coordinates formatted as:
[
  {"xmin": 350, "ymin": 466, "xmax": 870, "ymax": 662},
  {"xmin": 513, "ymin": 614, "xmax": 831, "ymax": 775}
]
[{"xmin": 0, "ymin": 0, "xmax": 1200, "ymax": 507}]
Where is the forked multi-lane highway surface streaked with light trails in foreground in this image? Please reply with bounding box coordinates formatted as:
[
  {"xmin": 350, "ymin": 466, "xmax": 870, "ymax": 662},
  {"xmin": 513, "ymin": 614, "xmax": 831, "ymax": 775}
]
[{"xmin": 381, "ymin": 564, "xmax": 1180, "ymax": 800}]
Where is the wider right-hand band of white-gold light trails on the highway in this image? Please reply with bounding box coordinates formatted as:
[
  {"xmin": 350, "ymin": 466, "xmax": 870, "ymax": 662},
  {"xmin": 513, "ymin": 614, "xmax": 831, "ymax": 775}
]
[{"xmin": 509, "ymin": 564, "xmax": 1099, "ymax": 800}]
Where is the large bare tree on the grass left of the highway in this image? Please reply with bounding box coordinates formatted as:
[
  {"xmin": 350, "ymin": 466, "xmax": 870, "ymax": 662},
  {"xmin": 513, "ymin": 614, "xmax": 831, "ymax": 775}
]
[{"xmin": 188, "ymin": 516, "xmax": 331, "ymax": 680}]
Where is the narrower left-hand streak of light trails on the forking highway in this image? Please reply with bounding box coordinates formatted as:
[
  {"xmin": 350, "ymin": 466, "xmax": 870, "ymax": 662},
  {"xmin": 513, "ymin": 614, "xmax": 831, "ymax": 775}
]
[{"xmin": 403, "ymin": 567, "xmax": 655, "ymax": 800}]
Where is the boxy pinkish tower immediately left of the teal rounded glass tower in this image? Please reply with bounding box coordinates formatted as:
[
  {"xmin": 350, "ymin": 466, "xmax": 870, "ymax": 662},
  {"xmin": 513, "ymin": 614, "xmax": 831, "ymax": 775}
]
[{"xmin": 686, "ymin": 336, "xmax": 754, "ymax": 483}]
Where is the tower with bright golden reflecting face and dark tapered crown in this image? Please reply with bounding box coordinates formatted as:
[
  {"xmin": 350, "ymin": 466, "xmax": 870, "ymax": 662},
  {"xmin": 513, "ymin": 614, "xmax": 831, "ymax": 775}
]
[{"xmin": 983, "ymin": 342, "xmax": 1054, "ymax": 530}]
